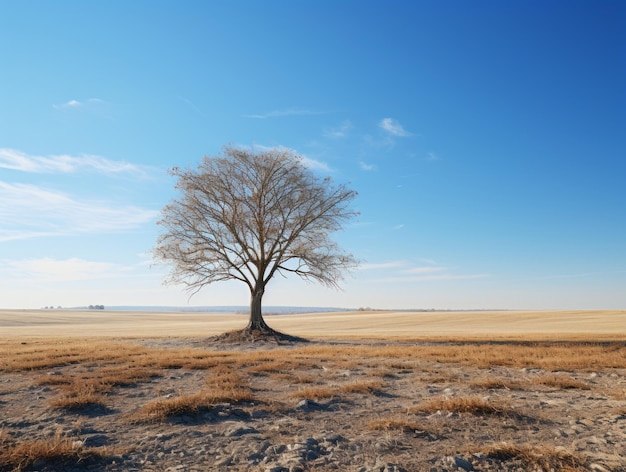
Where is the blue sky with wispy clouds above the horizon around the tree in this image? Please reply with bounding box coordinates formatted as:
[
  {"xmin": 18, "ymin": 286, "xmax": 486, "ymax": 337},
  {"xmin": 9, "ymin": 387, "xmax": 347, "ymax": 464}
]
[{"xmin": 0, "ymin": 0, "xmax": 626, "ymax": 309}]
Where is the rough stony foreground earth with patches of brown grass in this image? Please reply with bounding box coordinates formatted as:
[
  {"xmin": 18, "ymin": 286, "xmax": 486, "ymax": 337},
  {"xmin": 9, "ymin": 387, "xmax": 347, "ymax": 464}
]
[{"xmin": 0, "ymin": 338, "xmax": 626, "ymax": 472}]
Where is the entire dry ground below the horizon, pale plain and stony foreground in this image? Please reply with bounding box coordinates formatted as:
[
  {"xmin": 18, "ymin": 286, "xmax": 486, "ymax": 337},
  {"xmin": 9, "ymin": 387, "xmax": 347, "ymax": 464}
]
[{"xmin": 0, "ymin": 310, "xmax": 626, "ymax": 472}]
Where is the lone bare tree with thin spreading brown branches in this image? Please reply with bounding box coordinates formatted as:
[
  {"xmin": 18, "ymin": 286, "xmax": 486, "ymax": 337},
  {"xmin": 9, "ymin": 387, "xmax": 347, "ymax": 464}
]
[{"xmin": 154, "ymin": 147, "xmax": 357, "ymax": 334}]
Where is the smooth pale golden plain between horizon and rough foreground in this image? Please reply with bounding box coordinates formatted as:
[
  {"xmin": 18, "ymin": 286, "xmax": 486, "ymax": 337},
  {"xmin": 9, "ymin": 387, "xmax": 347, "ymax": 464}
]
[{"xmin": 0, "ymin": 310, "xmax": 626, "ymax": 340}]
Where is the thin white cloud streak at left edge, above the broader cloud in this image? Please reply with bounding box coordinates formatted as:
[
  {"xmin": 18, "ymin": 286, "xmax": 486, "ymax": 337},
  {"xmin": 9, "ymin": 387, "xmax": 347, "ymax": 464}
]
[{"xmin": 0, "ymin": 148, "xmax": 147, "ymax": 176}]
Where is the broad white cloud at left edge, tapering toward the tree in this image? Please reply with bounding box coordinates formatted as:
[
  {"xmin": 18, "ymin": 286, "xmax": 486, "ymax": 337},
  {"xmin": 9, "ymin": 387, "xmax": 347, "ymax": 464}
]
[{"xmin": 0, "ymin": 181, "xmax": 159, "ymax": 242}]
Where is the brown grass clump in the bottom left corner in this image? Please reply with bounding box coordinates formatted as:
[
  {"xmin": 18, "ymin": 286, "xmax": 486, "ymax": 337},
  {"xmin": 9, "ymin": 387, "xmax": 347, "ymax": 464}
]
[{"xmin": 0, "ymin": 433, "xmax": 114, "ymax": 472}]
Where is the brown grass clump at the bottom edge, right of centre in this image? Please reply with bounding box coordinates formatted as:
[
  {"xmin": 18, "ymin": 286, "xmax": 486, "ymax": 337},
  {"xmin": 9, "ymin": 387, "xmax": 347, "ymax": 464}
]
[{"xmin": 482, "ymin": 443, "xmax": 587, "ymax": 472}]
